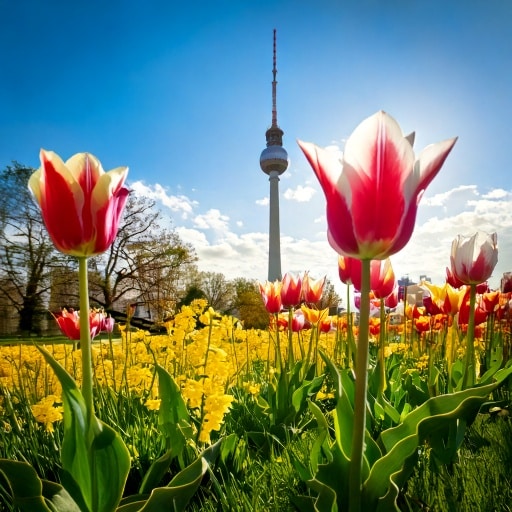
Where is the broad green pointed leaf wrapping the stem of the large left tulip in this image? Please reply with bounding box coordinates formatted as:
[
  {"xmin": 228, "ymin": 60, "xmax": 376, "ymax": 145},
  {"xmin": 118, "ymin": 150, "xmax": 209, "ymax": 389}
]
[{"xmin": 38, "ymin": 347, "xmax": 130, "ymax": 512}]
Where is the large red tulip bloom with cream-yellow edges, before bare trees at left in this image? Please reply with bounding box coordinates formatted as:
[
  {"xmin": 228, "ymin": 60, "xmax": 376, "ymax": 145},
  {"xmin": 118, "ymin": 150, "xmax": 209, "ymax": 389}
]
[{"xmin": 29, "ymin": 149, "xmax": 129, "ymax": 257}]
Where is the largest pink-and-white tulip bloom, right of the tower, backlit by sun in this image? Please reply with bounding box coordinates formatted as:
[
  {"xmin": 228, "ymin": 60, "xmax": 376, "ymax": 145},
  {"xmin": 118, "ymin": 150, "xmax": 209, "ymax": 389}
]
[{"xmin": 299, "ymin": 111, "xmax": 457, "ymax": 259}]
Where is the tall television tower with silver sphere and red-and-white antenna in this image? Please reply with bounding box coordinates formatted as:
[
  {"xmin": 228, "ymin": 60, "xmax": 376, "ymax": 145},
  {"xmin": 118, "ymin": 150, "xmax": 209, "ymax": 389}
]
[{"xmin": 260, "ymin": 29, "xmax": 288, "ymax": 281}]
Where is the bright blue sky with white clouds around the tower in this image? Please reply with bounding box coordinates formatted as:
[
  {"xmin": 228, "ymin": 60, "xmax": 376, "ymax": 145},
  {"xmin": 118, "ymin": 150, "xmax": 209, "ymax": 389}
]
[{"xmin": 0, "ymin": 0, "xmax": 512, "ymax": 296}]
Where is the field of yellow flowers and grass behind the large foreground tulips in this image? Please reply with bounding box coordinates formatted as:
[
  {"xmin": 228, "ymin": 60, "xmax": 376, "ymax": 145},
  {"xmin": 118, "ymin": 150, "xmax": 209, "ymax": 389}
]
[{"xmin": 0, "ymin": 294, "xmax": 512, "ymax": 511}]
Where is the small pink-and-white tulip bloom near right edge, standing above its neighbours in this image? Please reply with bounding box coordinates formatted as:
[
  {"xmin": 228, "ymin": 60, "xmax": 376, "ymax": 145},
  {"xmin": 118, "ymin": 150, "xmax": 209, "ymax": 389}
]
[{"xmin": 450, "ymin": 231, "xmax": 498, "ymax": 284}]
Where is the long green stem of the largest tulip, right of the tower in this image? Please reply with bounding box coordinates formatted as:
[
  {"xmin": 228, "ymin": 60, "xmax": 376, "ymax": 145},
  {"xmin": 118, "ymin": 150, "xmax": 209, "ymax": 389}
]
[{"xmin": 349, "ymin": 260, "xmax": 371, "ymax": 512}]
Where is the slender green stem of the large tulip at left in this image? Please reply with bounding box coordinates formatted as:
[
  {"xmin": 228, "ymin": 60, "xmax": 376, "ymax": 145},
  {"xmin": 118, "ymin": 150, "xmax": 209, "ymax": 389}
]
[{"xmin": 78, "ymin": 256, "xmax": 94, "ymax": 421}]
